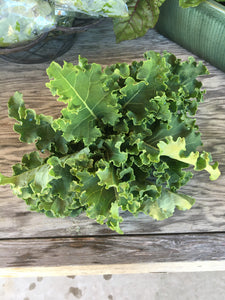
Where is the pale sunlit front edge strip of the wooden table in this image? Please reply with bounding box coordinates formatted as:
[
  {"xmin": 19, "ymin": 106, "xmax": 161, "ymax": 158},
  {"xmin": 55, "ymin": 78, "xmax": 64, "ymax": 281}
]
[{"xmin": 3, "ymin": 260, "xmax": 225, "ymax": 278}]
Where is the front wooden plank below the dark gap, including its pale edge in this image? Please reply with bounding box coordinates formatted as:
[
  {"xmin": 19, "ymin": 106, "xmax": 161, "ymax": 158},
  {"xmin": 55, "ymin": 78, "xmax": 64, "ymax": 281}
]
[{"xmin": 0, "ymin": 233, "xmax": 225, "ymax": 276}]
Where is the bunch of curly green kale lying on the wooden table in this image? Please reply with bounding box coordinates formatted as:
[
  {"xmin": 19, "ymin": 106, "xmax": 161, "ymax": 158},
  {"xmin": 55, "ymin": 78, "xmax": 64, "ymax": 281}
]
[{"xmin": 0, "ymin": 51, "xmax": 220, "ymax": 233}]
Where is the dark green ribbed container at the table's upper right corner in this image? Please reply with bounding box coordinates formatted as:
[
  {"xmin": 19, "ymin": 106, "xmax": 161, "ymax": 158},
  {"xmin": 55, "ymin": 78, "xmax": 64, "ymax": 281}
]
[{"xmin": 156, "ymin": 0, "xmax": 225, "ymax": 72}]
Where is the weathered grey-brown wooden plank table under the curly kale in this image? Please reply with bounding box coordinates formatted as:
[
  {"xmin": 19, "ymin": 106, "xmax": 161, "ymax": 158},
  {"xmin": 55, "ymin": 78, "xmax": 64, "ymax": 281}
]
[{"xmin": 0, "ymin": 20, "xmax": 225, "ymax": 276}]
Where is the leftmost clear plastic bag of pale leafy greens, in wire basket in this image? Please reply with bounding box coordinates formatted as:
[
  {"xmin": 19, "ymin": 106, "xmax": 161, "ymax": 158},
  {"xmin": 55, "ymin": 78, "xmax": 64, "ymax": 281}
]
[{"xmin": 0, "ymin": 0, "xmax": 55, "ymax": 47}]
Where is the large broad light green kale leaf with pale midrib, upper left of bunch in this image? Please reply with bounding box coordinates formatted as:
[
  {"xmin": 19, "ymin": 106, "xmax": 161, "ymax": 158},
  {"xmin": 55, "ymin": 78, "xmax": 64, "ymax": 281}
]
[{"xmin": 47, "ymin": 62, "xmax": 120, "ymax": 145}]
